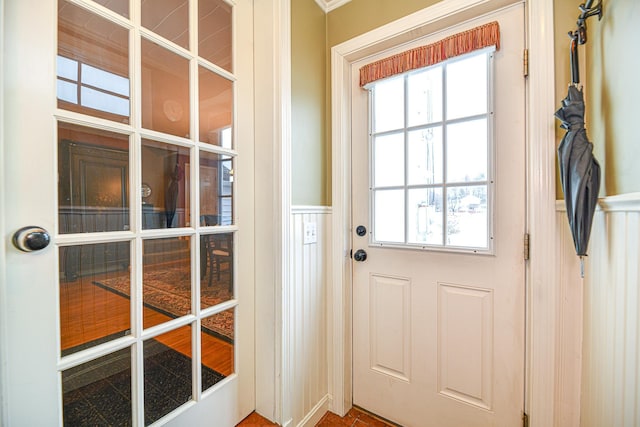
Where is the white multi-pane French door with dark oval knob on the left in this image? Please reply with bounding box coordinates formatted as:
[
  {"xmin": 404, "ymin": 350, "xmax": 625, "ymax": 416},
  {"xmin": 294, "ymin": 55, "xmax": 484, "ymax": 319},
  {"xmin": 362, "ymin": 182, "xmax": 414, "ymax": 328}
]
[{"xmin": 1, "ymin": 0, "xmax": 254, "ymax": 426}]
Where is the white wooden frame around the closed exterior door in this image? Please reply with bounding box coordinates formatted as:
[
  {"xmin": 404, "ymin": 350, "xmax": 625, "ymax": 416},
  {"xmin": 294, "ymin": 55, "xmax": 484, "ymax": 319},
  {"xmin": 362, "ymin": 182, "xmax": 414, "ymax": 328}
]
[{"xmin": 327, "ymin": 0, "xmax": 560, "ymax": 427}]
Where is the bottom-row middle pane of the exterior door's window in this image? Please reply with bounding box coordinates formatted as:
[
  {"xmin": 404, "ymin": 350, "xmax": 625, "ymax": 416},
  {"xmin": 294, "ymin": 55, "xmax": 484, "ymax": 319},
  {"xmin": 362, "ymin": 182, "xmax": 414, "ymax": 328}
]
[{"xmin": 408, "ymin": 188, "xmax": 444, "ymax": 245}]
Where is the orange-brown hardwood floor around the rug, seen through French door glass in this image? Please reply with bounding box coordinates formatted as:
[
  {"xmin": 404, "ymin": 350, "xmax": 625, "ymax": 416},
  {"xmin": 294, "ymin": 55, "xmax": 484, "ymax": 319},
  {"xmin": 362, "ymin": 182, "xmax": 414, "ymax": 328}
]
[{"xmin": 60, "ymin": 273, "xmax": 234, "ymax": 376}]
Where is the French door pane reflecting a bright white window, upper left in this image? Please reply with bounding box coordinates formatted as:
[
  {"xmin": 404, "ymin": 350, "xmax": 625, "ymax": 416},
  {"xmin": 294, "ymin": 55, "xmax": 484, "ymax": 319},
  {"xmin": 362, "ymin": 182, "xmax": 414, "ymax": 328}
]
[{"xmin": 58, "ymin": 0, "xmax": 130, "ymax": 123}]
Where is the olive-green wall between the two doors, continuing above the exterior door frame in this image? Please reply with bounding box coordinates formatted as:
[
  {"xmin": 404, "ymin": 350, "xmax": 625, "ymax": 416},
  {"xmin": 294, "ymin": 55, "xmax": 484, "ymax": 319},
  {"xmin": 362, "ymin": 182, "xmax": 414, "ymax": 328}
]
[{"xmin": 291, "ymin": 0, "xmax": 438, "ymax": 206}]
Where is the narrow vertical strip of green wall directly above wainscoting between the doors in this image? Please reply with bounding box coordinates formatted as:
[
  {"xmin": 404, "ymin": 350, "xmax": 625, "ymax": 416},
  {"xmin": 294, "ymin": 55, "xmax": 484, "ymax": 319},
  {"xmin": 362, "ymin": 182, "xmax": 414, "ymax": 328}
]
[{"xmin": 291, "ymin": 0, "xmax": 331, "ymax": 206}]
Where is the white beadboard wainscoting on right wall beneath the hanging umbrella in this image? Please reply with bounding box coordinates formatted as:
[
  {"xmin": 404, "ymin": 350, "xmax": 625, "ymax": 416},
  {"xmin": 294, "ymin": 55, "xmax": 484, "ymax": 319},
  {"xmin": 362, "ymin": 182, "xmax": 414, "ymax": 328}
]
[{"xmin": 556, "ymin": 193, "xmax": 640, "ymax": 427}]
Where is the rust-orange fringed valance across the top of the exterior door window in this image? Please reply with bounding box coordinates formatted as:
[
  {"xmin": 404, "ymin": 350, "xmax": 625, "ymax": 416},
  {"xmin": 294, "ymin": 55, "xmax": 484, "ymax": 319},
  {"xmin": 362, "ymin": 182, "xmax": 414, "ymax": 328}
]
[{"xmin": 360, "ymin": 22, "xmax": 500, "ymax": 87}]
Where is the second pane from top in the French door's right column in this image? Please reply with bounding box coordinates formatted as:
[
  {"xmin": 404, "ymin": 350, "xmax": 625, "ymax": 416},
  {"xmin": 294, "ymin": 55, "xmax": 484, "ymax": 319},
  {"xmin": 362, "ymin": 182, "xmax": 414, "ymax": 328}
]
[{"xmin": 198, "ymin": 67, "xmax": 233, "ymax": 148}]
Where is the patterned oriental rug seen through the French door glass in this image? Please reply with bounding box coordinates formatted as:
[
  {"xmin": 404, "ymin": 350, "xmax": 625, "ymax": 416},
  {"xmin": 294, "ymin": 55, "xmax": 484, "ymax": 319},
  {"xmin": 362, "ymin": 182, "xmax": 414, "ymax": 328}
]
[{"xmin": 93, "ymin": 267, "xmax": 234, "ymax": 343}]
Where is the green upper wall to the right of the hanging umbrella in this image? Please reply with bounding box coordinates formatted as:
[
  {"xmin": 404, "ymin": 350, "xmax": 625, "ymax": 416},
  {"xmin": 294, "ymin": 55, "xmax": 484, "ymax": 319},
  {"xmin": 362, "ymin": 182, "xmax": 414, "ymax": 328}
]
[{"xmin": 584, "ymin": 0, "xmax": 640, "ymax": 196}]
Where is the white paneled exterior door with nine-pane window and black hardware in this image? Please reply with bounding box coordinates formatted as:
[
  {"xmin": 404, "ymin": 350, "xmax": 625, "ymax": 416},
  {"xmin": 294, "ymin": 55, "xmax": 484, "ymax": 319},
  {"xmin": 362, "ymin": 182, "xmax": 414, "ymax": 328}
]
[{"xmin": 352, "ymin": 4, "xmax": 525, "ymax": 427}]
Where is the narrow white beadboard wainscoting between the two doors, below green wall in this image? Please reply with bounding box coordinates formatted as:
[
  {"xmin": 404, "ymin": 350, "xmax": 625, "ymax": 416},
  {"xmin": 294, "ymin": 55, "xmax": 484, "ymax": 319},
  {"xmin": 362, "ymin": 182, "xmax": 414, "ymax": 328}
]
[{"xmin": 288, "ymin": 206, "xmax": 331, "ymax": 426}]
